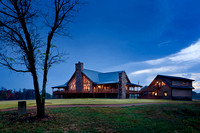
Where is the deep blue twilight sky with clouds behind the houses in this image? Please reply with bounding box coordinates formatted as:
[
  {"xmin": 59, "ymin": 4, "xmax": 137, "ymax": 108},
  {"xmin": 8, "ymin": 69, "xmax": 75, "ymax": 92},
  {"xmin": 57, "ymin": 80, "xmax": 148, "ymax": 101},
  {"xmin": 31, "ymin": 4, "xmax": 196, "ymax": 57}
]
[{"xmin": 0, "ymin": 0, "xmax": 200, "ymax": 93}]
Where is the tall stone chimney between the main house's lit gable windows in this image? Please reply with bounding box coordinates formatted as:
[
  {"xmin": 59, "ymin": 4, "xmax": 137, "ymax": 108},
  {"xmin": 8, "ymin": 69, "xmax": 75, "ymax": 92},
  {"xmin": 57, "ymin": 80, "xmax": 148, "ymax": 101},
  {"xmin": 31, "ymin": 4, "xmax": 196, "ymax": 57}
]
[{"xmin": 75, "ymin": 61, "xmax": 83, "ymax": 90}]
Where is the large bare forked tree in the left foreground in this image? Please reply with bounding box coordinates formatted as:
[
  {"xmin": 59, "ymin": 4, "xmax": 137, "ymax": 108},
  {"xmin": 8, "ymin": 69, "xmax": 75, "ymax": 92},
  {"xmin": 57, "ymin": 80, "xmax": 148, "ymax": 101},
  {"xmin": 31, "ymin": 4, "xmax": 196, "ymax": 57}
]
[{"xmin": 0, "ymin": 0, "xmax": 79, "ymax": 117}]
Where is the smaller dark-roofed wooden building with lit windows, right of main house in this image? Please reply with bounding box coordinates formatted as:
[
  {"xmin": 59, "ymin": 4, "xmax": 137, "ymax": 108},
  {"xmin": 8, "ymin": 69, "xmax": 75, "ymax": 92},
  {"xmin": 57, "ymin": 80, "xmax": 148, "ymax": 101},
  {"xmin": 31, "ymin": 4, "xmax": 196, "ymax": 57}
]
[{"xmin": 141, "ymin": 75, "xmax": 194, "ymax": 100}]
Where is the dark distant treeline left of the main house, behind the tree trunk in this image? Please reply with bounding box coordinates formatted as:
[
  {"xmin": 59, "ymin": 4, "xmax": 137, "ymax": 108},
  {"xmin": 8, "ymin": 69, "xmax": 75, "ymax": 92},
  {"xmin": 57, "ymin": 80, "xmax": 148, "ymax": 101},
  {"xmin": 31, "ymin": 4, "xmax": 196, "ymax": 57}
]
[{"xmin": 0, "ymin": 87, "xmax": 52, "ymax": 100}]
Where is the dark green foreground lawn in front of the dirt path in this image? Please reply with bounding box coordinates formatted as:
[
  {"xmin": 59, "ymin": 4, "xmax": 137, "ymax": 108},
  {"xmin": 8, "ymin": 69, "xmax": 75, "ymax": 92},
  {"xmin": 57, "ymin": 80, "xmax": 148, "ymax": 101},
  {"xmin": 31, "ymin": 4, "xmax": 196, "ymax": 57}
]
[{"xmin": 0, "ymin": 103, "xmax": 200, "ymax": 133}]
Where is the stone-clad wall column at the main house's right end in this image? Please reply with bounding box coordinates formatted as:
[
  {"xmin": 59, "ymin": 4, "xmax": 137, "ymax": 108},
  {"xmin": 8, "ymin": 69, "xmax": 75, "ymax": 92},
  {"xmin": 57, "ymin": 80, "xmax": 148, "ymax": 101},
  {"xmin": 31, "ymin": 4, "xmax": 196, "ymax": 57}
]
[{"xmin": 118, "ymin": 72, "xmax": 127, "ymax": 99}]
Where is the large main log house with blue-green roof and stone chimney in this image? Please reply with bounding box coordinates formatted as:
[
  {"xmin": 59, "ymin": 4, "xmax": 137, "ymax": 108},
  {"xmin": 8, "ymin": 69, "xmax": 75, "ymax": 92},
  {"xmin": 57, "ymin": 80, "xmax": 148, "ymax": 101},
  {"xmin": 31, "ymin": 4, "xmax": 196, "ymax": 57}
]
[{"xmin": 52, "ymin": 62, "xmax": 142, "ymax": 99}]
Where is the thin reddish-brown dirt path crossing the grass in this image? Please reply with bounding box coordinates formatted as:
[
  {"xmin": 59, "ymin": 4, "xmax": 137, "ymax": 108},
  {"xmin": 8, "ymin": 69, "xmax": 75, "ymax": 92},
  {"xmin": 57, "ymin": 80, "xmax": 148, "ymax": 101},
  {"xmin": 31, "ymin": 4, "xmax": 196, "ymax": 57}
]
[{"xmin": 0, "ymin": 103, "xmax": 172, "ymax": 112}]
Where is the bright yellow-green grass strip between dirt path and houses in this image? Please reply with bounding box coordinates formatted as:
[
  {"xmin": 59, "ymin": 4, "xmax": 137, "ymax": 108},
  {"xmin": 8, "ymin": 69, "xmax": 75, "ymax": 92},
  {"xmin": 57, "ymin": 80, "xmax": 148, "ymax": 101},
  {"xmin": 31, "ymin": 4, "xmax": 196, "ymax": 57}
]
[{"xmin": 0, "ymin": 98, "xmax": 200, "ymax": 109}]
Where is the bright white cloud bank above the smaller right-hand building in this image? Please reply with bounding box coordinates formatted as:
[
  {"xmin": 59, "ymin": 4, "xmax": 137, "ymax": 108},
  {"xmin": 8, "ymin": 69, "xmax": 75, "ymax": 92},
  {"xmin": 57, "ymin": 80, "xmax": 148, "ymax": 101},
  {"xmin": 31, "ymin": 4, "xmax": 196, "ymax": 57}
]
[{"xmin": 107, "ymin": 39, "xmax": 200, "ymax": 92}]
